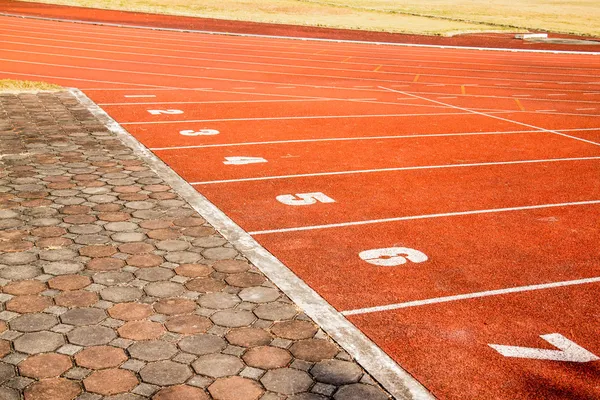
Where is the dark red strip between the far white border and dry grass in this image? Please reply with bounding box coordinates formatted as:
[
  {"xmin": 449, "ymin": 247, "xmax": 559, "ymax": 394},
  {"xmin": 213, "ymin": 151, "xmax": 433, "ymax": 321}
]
[{"xmin": 0, "ymin": 0, "xmax": 597, "ymax": 51}]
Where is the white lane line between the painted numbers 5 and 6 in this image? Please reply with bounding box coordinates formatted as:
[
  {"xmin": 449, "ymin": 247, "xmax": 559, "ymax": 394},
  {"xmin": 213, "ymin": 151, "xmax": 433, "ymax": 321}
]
[{"xmin": 248, "ymin": 200, "xmax": 600, "ymax": 236}]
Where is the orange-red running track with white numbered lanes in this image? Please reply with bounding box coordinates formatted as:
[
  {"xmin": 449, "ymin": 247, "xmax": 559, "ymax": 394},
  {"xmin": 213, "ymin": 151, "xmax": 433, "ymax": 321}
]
[{"xmin": 0, "ymin": 13, "xmax": 600, "ymax": 399}]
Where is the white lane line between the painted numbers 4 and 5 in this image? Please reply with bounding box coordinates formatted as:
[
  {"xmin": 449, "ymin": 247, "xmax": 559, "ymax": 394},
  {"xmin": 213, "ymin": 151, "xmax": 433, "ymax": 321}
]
[{"xmin": 190, "ymin": 156, "xmax": 600, "ymax": 185}]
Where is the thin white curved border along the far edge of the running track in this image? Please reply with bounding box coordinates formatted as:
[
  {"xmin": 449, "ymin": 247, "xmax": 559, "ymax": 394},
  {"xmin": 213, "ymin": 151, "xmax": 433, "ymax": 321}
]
[{"xmin": 0, "ymin": 12, "xmax": 600, "ymax": 56}]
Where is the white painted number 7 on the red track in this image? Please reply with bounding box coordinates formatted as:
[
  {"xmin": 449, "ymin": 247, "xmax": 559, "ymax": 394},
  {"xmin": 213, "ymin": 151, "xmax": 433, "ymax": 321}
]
[{"xmin": 488, "ymin": 333, "xmax": 600, "ymax": 363}]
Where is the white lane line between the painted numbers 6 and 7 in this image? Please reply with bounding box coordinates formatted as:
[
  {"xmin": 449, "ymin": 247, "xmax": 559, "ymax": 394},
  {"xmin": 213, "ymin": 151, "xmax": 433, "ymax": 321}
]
[{"xmin": 342, "ymin": 277, "xmax": 600, "ymax": 316}]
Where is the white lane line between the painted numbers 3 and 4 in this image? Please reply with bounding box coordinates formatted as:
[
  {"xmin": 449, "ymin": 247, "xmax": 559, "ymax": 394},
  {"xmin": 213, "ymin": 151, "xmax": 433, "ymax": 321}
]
[{"xmin": 150, "ymin": 130, "xmax": 539, "ymax": 151}]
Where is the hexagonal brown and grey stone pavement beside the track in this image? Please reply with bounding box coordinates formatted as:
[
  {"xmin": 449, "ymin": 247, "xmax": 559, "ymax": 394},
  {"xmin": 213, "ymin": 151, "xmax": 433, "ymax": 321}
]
[{"xmin": 0, "ymin": 92, "xmax": 388, "ymax": 400}]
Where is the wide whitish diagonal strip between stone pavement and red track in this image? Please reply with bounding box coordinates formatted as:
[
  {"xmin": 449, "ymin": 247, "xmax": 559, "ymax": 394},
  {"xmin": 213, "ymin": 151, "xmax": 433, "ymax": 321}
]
[{"xmin": 69, "ymin": 89, "xmax": 435, "ymax": 400}]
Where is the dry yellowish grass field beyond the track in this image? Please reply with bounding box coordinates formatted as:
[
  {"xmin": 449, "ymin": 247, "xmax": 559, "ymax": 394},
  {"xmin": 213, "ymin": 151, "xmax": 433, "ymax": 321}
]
[{"xmin": 19, "ymin": 0, "xmax": 600, "ymax": 36}]
